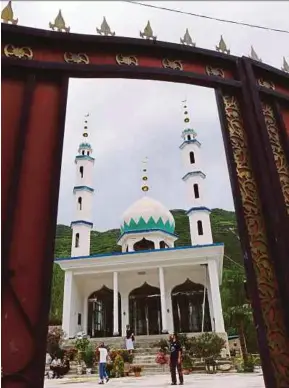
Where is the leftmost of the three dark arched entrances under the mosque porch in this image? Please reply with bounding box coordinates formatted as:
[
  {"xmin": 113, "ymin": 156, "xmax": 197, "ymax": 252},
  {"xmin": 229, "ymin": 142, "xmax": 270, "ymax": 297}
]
[{"xmin": 87, "ymin": 286, "xmax": 121, "ymax": 338}]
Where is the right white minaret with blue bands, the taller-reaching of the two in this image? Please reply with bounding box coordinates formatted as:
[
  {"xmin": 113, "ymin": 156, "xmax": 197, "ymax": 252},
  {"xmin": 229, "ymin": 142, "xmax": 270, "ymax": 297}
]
[{"xmin": 180, "ymin": 101, "xmax": 213, "ymax": 245}]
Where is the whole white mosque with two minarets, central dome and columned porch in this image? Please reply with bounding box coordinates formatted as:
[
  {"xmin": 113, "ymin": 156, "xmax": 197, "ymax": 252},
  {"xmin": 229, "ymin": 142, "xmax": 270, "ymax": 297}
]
[{"xmin": 56, "ymin": 106, "xmax": 226, "ymax": 338}]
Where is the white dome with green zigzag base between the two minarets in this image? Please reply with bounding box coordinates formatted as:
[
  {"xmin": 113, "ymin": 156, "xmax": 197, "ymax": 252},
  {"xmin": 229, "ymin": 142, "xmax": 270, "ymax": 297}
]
[{"xmin": 120, "ymin": 196, "xmax": 175, "ymax": 233}]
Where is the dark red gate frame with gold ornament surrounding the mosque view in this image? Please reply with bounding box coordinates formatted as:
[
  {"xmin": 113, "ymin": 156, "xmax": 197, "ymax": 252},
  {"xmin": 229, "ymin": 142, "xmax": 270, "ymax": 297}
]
[{"xmin": 1, "ymin": 25, "xmax": 289, "ymax": 388}]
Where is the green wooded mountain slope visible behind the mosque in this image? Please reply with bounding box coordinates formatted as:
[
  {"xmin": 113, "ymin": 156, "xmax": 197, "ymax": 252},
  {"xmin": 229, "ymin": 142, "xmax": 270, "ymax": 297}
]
[{"xmin": 50, "ymin": 209, "xmax": 243, "ymax": 324}]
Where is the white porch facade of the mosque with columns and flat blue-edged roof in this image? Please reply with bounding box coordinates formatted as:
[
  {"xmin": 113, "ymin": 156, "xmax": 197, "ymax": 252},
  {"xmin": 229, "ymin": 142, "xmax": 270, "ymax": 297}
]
[{"xmin": 57, "ymin": 244, "xmax": 225, "ymax": 338}]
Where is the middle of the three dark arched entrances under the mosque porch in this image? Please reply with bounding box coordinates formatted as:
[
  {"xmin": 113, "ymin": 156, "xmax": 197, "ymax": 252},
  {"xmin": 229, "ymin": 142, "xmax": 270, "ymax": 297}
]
[{"xmin": 129, "ymin": 282, "xmax": 162, "ymax": 335}]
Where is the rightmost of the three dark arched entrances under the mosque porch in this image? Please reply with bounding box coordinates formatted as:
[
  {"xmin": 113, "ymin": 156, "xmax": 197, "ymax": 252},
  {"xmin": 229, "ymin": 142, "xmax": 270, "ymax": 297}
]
[{"xmin": 172, "ymin": 279, "xmax": 212, "ymax": 333}]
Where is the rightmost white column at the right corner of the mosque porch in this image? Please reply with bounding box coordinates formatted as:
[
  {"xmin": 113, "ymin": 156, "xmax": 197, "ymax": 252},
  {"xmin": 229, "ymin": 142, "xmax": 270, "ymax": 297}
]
[{"xmin": 208, "ymin": 260, "xmax": 225, "ymax": 333}]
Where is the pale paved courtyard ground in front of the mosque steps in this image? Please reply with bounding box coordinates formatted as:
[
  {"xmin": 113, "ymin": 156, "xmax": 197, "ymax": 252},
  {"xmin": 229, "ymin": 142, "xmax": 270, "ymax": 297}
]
[{"xmin": 44, "ymin": 373, "xmax": 265, "ymax": 388}]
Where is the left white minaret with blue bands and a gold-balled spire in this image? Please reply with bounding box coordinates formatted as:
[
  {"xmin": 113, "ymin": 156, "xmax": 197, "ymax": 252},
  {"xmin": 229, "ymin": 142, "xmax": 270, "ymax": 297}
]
[{"xmin": 71, "ymin": 114, "xmax": 94, "ymax": 257}]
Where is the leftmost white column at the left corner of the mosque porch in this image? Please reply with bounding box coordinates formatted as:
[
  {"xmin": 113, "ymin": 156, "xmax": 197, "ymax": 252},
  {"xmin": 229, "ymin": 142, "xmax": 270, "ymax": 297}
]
[{"xmin": 62, "ymin": 271, "xmax": 73, "ymax": 338}]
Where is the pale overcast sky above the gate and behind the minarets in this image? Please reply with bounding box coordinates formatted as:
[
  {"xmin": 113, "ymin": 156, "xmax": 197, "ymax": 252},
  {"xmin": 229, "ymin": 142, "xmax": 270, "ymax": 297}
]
[{"xmin": 11, "ymin": 1, "xmax": 289, "ymax": 230}]
